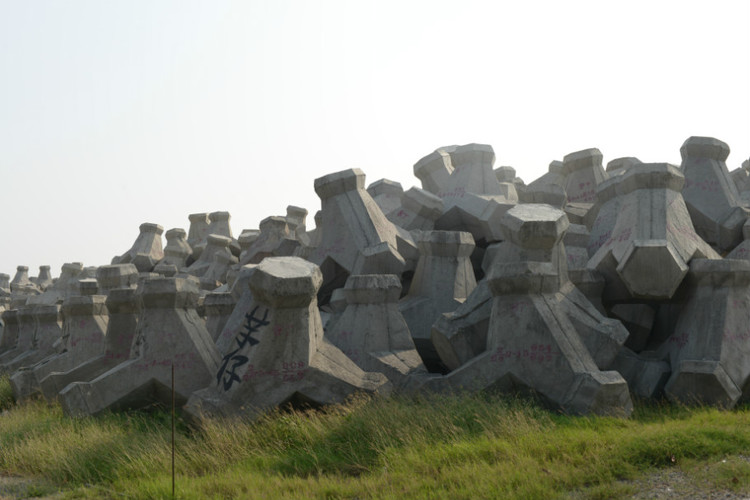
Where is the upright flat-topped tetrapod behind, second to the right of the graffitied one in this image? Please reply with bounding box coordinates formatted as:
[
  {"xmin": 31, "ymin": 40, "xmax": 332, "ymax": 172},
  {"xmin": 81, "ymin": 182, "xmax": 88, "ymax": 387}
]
[{"xmin": 399, "ymin": 231, "xmax": 476, "ymax": 371}]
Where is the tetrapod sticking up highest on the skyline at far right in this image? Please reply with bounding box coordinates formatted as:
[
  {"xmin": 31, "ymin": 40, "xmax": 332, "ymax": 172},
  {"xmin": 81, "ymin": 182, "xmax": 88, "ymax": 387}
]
[{"xmin": 680, "ymin": 137, "xmax": 750, "ymax": 251}]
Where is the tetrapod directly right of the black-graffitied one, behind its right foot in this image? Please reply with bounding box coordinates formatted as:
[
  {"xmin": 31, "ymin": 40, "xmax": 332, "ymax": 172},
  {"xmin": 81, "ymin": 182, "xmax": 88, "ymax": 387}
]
[{"xmin": 325, "ymin": 274, "xmax": 427, "ymax": 388}]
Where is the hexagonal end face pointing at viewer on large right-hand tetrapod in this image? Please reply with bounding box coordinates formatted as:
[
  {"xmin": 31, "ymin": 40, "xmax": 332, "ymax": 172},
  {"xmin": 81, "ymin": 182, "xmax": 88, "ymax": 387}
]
[{"xmin": 617, "ymin": 240, "xmax": 688, "ymax": 300}]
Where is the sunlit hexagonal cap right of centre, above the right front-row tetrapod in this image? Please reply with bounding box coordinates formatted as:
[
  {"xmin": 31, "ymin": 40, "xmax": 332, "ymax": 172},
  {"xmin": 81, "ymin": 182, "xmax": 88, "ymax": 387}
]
[{"xmin": 500, "ymin": 203, "xmax": 570, "ymax": 248}]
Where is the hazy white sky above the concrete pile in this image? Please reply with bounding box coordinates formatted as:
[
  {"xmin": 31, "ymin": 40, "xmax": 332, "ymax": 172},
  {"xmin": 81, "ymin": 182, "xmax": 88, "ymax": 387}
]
[{"xmin": 0, "ymin": 0, "xmax": 750, "ymax": 277}]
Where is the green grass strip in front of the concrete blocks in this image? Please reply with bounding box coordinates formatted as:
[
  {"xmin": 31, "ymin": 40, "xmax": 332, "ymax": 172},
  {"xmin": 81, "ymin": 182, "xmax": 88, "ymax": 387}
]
[{"xmin": 0, "ymin": 378, "xmax": 750, "ymax": 499}]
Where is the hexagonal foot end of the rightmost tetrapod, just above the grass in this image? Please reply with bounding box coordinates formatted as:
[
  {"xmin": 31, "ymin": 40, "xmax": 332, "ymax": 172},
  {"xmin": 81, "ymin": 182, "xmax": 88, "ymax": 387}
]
[{"xmin": 664, "ymin": 359, "xmax": 742, "ymax": 408}]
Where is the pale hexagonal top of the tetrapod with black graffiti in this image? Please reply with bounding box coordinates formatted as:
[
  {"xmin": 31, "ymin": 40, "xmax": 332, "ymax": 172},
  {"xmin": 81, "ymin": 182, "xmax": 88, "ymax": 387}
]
[{"xmin": 248, "ymin": 257, "xmax": 323, "ymax": 309}]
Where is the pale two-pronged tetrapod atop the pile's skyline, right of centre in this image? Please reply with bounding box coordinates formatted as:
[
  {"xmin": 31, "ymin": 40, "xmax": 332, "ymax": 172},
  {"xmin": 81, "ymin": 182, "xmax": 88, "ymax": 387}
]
[{"xmin": 414, "ymin": 144, "xmax": 518, "ymax": 242}]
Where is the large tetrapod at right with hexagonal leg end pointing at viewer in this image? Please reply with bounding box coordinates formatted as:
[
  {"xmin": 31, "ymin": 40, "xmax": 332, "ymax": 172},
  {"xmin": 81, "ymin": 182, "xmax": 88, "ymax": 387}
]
[{"xmin": 588, "ymin": 163, "xmax": 720, "ymax": 302}]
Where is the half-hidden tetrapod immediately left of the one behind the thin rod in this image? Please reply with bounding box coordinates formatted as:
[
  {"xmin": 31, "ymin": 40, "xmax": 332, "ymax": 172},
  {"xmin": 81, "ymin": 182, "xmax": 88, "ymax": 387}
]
[{"xmin": 39, "ymin": 287, "xmax": 141, "ymax": 401}]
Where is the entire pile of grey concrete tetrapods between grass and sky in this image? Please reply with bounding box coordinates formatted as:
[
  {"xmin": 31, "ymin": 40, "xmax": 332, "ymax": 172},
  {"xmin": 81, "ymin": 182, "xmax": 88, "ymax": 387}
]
[{"xmin": 0, "ymin": 137, "xmax": 750, "ymax": 419}]
